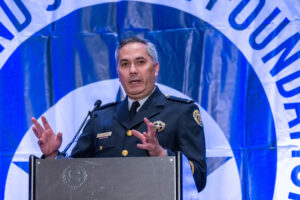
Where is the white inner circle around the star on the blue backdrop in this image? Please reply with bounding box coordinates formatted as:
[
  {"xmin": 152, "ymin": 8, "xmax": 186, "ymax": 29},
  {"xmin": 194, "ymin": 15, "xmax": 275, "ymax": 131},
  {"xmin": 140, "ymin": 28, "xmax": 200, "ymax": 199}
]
[{"xmin": 5, "ymin": 79, "xmax": 241, "ymax": 200}]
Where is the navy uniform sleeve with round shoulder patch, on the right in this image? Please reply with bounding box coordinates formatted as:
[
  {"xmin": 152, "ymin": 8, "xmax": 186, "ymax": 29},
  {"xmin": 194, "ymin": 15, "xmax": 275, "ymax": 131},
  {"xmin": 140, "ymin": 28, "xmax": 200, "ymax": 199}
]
[{"xmin": 177, "ymin": 104, "xmax": 207, "ymax": 192}]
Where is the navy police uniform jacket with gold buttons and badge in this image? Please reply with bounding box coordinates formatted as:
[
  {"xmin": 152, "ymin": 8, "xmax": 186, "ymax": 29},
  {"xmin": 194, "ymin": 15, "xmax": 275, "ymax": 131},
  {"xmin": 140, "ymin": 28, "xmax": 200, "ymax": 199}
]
[{"xmin": 71, "ymin": 87, "xmax": 206, "ymax": 191}]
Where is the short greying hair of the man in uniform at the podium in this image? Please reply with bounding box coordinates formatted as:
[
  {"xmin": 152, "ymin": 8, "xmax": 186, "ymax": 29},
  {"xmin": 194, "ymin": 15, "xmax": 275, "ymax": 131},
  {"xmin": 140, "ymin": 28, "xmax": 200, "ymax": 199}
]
[{"xmin": 115, "ymin": 36, "xmax": 158, "ymax": 63}]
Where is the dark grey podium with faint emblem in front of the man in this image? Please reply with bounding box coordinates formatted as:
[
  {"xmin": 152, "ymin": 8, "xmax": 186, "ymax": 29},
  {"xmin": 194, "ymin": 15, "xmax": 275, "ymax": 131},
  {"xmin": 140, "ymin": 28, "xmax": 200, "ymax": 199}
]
[{"xmin": 29, "ymin": 153, "xmax": 182, "ymax": 200}]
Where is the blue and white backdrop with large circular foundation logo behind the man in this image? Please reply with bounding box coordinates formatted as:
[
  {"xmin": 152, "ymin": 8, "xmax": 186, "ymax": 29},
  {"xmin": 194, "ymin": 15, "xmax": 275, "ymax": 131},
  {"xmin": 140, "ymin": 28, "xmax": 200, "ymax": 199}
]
[{"xmin": 0, "ymin": 0, "xmax": 299, "ymax": 200}]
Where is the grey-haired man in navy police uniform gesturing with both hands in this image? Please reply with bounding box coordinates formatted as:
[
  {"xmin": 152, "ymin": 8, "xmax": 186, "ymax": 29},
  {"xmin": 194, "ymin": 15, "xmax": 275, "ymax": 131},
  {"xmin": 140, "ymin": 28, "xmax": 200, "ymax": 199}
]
[{"xmin": 32, "ymin": 37, "xmax": 206, "ymax": 191}]
